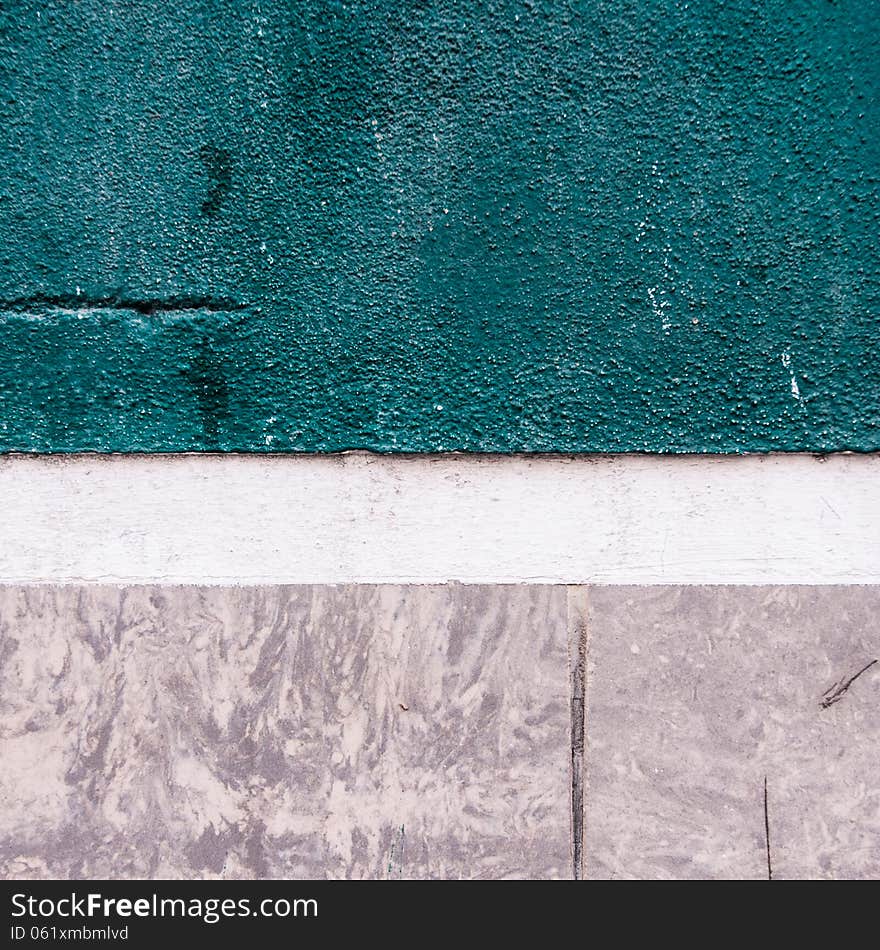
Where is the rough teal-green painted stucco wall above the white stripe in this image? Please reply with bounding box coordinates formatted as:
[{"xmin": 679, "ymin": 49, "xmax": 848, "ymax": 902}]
[{"xmin": 0, "ymin": 0, "xmax": 880, "ymax": 452}]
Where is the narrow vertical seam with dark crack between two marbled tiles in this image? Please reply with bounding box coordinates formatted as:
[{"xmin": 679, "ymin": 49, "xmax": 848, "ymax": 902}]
[{"xmin": 567, "ymin": 587, "xmax": 588, "ymax": 881}]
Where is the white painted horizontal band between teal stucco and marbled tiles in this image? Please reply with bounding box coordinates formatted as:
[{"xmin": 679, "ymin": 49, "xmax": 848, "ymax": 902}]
[{"xmin": 0, "ymin": 453, "xmax": 880, "ymax": 584}]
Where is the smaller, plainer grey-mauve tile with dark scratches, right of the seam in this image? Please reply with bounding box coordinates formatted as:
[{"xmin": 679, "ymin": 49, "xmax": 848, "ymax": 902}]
[{"xmin": 585, "ymin": 587, "xmax": 880, "ymax": 878}]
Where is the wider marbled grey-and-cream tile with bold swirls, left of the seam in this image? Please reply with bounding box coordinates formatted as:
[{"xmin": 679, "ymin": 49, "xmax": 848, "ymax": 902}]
[{"xmin": 0, "ymin": 585, "xmax": 571, "ymax": 878}]
